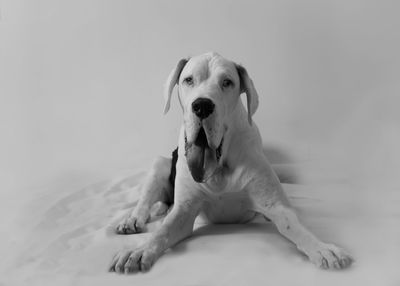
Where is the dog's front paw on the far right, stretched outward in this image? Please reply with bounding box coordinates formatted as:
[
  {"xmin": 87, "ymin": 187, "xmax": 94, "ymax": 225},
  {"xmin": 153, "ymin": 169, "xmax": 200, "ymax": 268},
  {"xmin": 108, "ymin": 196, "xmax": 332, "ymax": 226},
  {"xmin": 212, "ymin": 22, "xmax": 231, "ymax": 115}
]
[{"xmin": 307, "ymin": 243, "xmax": 353, "ymax": 269}]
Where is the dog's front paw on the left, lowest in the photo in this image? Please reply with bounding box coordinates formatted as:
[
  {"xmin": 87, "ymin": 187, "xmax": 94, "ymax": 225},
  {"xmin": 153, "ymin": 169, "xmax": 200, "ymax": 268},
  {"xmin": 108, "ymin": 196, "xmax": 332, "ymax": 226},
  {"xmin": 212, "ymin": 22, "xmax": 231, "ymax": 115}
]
[{"xmin": 109, "ymin": 246, "xmax": 159, "ymax": 274}]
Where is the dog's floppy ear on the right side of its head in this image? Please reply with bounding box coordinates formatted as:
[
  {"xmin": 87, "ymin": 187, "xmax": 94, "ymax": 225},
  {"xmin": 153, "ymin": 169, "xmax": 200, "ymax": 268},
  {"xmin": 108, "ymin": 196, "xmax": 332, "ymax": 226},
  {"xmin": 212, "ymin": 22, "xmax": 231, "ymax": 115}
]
[{"xmin": 236, "ymin": 64, "xmax": 258, "ymax": 125}]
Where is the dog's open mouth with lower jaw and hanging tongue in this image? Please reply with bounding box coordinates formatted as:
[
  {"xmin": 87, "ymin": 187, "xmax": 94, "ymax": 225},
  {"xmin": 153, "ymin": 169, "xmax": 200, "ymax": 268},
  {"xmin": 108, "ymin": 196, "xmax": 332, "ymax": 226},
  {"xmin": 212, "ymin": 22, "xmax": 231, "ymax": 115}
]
[{"xmin": 185, "ymin": 127, "xmax": 224, "ymax": 183}]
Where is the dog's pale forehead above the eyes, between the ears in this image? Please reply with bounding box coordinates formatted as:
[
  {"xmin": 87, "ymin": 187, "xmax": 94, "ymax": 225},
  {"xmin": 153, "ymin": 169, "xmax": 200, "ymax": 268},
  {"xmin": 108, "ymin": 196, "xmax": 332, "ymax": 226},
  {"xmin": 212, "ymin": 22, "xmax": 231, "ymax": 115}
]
[{"xmin": 182, "ymin": 53, "xmax": 239, "ymax": 79}]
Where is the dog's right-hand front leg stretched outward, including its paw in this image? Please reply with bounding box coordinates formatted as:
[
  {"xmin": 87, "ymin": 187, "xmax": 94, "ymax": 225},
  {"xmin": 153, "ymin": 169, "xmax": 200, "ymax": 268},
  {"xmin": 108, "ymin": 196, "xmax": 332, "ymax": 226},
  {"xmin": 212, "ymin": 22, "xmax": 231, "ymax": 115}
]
[{"xmin": 250, "ymin": 171, "xmax": 353, "ymax": 269}]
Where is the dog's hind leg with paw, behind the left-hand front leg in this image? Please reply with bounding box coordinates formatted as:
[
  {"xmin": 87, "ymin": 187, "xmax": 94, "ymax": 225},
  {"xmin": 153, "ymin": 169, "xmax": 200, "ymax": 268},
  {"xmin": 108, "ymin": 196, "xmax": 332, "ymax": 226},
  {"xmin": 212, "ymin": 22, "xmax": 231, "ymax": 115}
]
[{"xmin": 116, "ymin": 157, "xmax": 174, "ymax": 234}]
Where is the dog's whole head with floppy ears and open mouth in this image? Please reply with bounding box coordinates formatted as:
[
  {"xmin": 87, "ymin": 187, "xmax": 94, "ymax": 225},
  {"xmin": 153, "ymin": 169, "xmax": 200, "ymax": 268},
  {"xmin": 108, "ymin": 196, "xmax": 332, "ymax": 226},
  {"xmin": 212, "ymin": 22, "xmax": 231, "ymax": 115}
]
[{"xmin": 164, "ymin": 53, "xmax": 258, "ymax": 182}]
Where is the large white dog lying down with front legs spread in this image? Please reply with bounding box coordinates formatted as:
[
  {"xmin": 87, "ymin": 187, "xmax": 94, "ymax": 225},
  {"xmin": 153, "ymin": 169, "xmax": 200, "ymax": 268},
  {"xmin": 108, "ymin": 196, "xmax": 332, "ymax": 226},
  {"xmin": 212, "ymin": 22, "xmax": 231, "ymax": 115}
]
[{"xmin": 109, "ymin": 53, "xmax": 353, "ymax": 273}]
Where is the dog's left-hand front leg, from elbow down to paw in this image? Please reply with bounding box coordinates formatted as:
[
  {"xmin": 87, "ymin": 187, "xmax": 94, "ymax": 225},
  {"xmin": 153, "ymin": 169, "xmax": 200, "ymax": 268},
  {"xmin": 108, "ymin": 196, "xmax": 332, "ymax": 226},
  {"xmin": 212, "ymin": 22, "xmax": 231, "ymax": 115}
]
[{"xmin": 109, "ymin": 201, "xmax": 200, "ymax": 274}]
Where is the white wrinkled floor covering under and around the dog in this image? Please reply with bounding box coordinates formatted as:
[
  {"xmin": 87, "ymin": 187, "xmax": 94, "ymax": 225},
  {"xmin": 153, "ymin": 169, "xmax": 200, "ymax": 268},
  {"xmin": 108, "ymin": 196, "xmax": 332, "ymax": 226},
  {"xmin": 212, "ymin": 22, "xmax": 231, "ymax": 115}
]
[{"xmin": 0, "ymin": 165, "xmax": 400, "ymax": 285}]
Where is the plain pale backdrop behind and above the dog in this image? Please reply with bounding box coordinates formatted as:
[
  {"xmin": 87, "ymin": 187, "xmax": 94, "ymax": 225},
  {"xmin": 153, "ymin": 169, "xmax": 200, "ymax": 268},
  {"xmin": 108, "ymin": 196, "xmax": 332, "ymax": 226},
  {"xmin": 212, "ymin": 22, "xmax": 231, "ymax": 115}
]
[{"xmin": 0, "ymin": 0, "xmax": 400, "ymax": 284}]
